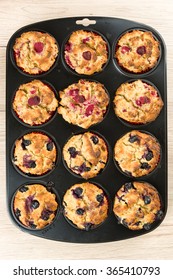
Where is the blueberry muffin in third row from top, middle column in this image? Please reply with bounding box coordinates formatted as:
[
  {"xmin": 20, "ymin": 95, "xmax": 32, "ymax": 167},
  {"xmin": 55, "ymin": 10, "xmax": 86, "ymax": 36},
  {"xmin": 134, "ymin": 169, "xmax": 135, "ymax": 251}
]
[{"xmin": 63, "ymin": 132, "xmax": 108, "ymax": 179}]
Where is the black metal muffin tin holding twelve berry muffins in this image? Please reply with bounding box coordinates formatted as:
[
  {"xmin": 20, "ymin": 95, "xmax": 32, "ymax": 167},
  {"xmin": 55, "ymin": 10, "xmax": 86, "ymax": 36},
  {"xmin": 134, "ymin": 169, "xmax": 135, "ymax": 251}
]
[{"xmin": 6, "ymin": 17, "xmax": 167, "ymax": 243}]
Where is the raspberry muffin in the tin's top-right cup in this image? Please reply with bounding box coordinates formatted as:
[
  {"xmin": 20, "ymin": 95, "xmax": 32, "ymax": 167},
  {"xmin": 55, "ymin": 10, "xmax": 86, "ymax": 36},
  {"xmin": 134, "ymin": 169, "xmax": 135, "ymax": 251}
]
[{"xmin": 115, "ymin": 30, "xmax": 160, "ymax": 74}]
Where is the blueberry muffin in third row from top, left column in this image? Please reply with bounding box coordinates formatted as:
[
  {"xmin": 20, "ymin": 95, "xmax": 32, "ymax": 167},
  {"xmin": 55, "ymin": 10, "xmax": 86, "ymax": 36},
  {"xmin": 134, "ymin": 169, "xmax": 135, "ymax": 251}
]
[{"xmin": 13, "ymin": 132, "xmax": 57, "ymax": 176}]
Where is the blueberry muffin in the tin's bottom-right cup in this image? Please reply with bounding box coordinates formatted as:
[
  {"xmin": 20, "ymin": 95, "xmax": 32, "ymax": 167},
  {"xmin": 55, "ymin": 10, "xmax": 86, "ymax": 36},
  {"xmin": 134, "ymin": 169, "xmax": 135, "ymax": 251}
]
[{"xmin": 113, "ymin": 182, "xmax": 163, "ymax": 230}]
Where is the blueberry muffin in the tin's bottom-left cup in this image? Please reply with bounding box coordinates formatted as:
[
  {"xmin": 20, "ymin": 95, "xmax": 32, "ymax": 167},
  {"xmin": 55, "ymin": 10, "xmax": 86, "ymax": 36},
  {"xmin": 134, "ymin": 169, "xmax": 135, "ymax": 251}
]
[{"xmin": 13, "ymin": 184, "xmax": 58, "ymax": 229}]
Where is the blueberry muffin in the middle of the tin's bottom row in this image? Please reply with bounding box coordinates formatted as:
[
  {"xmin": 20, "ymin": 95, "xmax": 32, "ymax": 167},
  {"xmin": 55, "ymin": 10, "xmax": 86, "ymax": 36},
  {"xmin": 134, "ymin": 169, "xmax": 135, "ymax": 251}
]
[{"xmin": 63, "ymin": 182, "xmax": 109, "ymax": 230}]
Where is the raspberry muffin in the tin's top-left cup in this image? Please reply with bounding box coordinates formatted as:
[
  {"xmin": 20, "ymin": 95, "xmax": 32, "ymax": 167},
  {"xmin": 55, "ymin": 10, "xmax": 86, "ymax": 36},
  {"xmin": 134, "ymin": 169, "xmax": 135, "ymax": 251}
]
[{"xmin": 13, "ymin": 31, "xmax": 59, "ymax": 74}]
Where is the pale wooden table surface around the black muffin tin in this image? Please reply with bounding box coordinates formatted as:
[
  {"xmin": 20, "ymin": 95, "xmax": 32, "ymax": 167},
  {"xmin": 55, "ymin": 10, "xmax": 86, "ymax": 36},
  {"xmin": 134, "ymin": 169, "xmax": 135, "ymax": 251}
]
[{"xmin": 0, "ymin": 0, "xmax": 173, "ymax": 260}]
